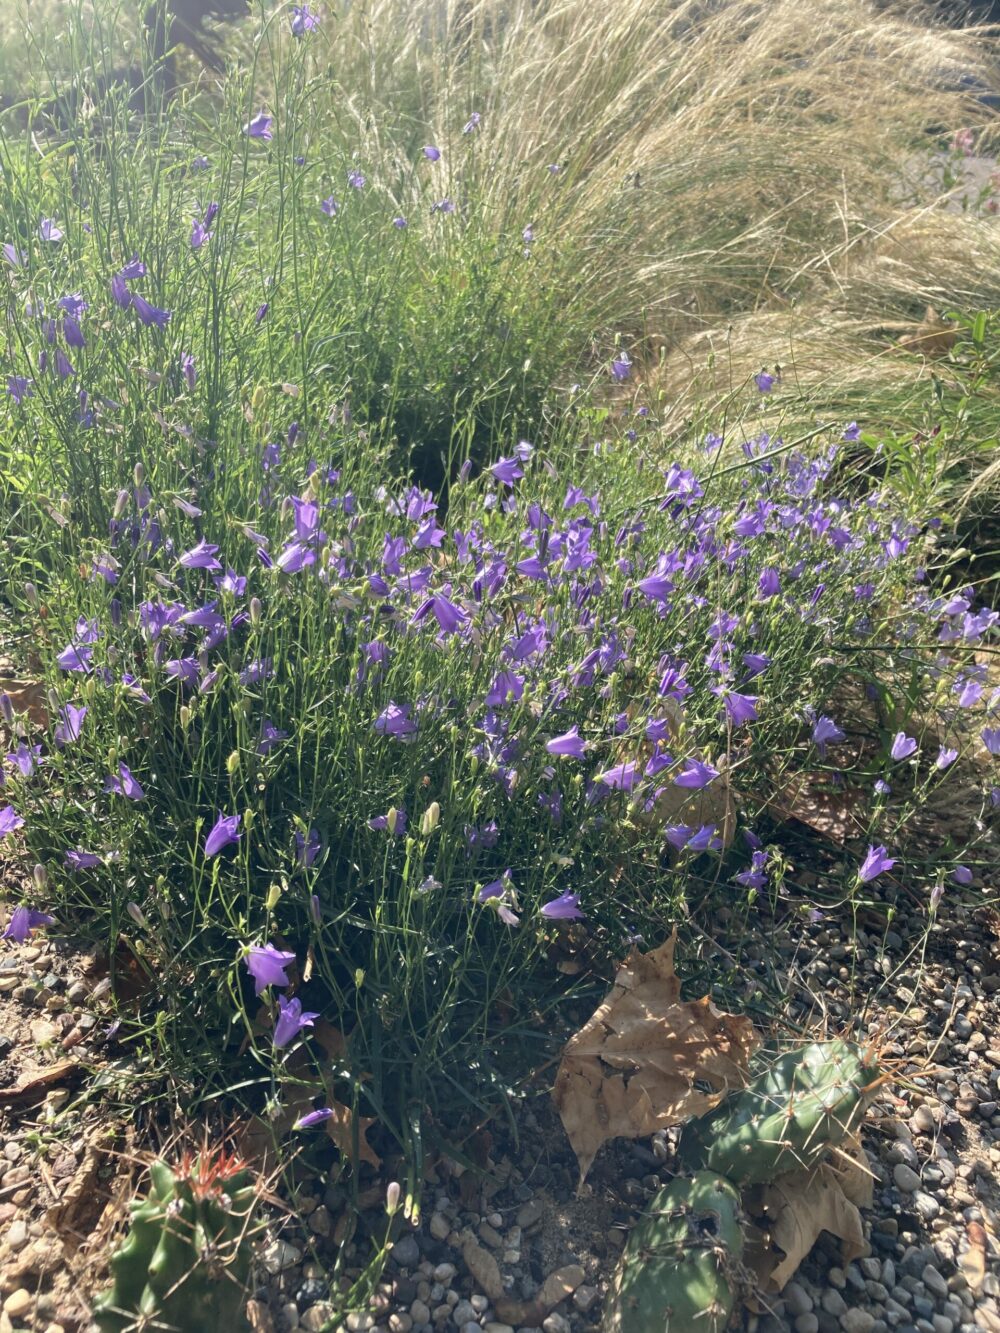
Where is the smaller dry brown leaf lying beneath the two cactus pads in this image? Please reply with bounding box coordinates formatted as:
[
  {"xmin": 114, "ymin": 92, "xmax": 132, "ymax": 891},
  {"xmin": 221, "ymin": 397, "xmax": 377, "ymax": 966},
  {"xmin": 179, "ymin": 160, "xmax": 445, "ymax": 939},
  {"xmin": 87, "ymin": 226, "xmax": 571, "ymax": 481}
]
[{"xmin": 761, "ymin": 1162, "xmax": 868, "ymax": 1292}]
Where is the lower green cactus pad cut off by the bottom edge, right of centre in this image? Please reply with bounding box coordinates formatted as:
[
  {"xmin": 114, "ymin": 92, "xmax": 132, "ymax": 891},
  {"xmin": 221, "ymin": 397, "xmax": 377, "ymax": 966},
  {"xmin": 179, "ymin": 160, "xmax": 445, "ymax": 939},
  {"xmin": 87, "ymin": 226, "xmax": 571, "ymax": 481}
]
[{"xmin": 603, "ymin": 1172, "xmax": 743, "ymax": 1333}]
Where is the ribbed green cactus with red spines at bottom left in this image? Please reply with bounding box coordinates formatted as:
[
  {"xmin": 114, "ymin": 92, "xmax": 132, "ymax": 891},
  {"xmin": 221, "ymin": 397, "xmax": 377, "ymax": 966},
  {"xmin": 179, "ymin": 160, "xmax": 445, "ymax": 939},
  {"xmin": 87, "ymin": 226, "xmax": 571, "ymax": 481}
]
[{"xmin": 93, "ymin": 1153, "xmax": 256, "ymax": 1333}]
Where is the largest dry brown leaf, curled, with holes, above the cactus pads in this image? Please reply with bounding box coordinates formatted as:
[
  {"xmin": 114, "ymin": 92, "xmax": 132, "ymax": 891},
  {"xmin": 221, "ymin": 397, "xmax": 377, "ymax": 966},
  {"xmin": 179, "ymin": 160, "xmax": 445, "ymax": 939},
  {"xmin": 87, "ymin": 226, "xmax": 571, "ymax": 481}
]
[{"xmin": 552, "ymin": 929, "xmax": 757, "ymax": 1184}]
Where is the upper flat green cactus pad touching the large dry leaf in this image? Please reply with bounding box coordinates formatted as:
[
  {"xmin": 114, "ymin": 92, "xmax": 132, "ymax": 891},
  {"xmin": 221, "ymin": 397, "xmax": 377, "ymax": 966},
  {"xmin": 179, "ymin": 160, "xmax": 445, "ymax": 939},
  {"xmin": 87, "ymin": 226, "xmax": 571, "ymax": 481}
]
[{"xmin": 679, "ymin": 1040, "xmax": 879, "ymax": 1185}]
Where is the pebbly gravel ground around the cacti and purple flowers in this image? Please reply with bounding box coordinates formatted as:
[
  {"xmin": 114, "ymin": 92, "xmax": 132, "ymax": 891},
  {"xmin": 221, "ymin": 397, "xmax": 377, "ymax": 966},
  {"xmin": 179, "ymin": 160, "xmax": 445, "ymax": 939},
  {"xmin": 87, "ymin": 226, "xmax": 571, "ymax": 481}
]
[{"xmin": 0, "ymin": 826, "xmax": 1000, "ymax": 1333}]
